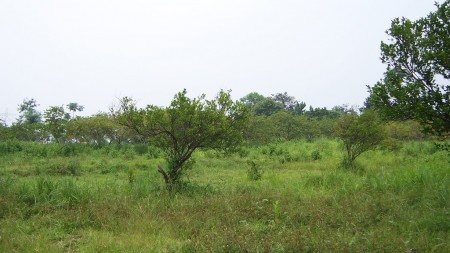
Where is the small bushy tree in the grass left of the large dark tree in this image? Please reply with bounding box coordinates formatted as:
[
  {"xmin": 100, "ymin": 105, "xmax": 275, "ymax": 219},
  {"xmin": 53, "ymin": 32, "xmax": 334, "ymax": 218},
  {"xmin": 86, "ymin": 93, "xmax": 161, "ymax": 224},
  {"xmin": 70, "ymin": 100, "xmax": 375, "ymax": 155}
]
[{"xmin": 336, "ymin": 110, "xmax": 385, "ymax": 167}]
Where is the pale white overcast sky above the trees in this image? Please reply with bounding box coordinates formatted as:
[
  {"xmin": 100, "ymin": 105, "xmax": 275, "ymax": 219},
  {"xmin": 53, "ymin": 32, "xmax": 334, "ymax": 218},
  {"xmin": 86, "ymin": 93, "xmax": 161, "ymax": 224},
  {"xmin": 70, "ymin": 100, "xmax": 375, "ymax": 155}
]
[{"xmin": 0, "ymin": 0, "xmax": 442, "ymax": 122}]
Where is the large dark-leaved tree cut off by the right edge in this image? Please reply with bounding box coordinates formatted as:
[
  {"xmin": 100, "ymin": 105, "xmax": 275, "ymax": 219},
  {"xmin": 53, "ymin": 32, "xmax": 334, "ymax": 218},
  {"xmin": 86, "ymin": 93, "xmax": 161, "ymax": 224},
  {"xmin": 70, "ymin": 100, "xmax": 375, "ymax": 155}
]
[{"xmin": 366, "ymin": 0, "xmax": 450, "ymax": 136}]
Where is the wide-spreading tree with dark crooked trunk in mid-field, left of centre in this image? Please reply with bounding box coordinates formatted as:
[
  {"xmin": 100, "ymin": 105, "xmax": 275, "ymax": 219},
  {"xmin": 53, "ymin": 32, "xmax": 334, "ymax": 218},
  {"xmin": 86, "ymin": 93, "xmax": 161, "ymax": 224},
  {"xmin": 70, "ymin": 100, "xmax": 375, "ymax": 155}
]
[{"xmin": 114, "ymin": 90, "xmax": 248, "ymax": 190}]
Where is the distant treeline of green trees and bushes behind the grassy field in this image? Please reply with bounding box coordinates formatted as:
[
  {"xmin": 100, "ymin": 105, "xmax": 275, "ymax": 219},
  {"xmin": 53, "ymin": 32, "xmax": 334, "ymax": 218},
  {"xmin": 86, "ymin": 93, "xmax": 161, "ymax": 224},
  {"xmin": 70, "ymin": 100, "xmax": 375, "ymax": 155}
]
[{"xmin": 0, "ymin": 92, "xmax": 425, "ymax": 146}]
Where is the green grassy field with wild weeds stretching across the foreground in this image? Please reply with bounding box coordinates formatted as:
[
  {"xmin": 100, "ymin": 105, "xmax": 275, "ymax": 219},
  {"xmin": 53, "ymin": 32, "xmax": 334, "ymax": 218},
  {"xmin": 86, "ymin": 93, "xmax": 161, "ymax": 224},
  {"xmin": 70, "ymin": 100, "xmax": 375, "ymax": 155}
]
[{"xmin": 0, "ymin": 140, "xmax": 450, "ymax": 252}]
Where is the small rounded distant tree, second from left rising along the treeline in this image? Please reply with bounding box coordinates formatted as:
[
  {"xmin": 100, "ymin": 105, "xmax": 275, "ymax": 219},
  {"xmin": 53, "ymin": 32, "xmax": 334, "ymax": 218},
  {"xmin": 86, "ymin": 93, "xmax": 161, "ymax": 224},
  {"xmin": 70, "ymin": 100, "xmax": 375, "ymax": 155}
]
[{"xmin": 44, "ymin": 106, "xmax": 70, "ymax": 142}]
